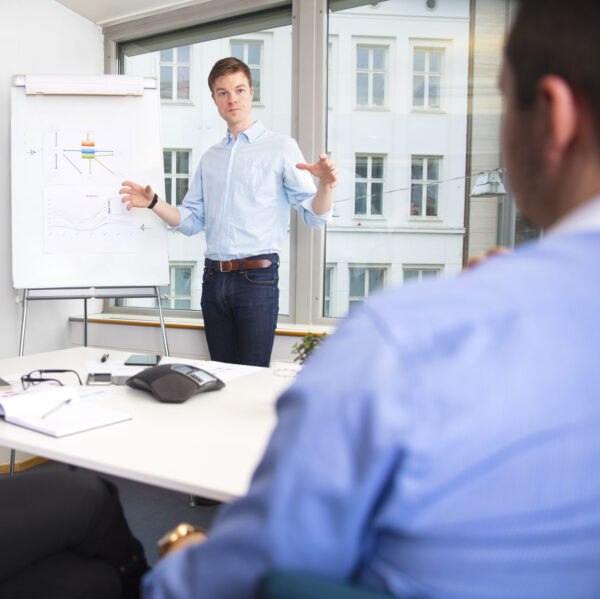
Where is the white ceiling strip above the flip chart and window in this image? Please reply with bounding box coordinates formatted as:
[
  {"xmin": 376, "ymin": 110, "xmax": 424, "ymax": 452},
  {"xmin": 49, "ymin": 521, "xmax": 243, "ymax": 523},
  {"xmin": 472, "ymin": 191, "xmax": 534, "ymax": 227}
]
[{"xmin": 57, "ymin": 0, "xmax": 212, "ymax": 27}]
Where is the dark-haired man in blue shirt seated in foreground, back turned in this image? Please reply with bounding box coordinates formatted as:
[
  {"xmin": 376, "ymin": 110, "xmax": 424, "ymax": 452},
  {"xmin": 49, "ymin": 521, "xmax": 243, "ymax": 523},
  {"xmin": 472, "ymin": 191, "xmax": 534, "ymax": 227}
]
[{"xmin": 144, "ymin": 0, "xmax": 600, "ymax": 599}]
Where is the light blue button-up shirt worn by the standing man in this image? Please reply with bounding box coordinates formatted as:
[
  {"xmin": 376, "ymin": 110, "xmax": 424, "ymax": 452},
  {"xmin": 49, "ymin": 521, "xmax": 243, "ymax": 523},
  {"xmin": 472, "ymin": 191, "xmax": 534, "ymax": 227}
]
[{"xmin": 173, "ymin": 121, "xmax": 332, "ymax": 260}]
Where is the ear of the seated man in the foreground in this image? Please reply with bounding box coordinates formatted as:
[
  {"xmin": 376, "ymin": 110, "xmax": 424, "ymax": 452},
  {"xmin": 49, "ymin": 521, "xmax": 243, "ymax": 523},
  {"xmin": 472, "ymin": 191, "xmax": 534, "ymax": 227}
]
[{"xmin": 538, "ymin": 75, "xmax": 579, "ymax": 163}]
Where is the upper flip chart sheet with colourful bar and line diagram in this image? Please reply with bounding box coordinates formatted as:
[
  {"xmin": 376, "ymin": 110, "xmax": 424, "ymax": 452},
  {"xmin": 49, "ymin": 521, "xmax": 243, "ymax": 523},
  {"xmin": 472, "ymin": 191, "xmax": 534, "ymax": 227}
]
[{"xmin": 43, "ymin": 125, "xmax": 134, "ymax": 185}]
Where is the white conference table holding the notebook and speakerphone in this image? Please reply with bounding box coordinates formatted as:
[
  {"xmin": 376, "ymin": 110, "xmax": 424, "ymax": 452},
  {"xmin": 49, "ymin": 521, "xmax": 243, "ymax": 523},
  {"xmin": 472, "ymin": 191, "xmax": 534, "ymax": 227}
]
[{"xmin": 0, "ymin": 347, "xmax": 293, "ymax": 501}]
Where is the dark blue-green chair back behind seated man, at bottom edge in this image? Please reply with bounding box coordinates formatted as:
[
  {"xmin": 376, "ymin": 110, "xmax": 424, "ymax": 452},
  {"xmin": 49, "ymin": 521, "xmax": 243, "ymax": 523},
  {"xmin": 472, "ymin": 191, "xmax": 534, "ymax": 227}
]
[{"xmin": 255, "ymin": 570, "xmax": 398, "ymax": 599}]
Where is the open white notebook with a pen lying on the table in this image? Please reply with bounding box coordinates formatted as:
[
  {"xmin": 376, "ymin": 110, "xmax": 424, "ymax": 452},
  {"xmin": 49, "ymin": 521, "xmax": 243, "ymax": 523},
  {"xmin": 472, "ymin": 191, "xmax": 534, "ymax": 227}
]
[{"xmin": 0, "ymin": 386, "xmax": 131, "ymax": 437}]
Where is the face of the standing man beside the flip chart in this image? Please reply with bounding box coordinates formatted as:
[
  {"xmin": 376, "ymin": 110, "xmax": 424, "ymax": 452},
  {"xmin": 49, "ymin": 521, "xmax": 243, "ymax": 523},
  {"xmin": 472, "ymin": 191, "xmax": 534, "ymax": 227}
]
[{"xmin": 212, "ymin": 71, "xmax": 254, "ymax": 132}]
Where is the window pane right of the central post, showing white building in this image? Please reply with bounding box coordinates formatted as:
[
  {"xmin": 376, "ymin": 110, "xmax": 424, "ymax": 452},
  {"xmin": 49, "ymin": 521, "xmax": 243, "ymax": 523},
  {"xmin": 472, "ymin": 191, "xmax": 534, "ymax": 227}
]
[{"xmin": 323, "ymin": 0, "xmax": 472, "ymax": 316}]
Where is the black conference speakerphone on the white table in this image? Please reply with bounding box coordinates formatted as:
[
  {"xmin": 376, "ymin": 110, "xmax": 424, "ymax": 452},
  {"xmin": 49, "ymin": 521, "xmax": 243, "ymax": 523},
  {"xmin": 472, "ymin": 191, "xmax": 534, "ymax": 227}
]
[{"xmin": 126, "ymin": 364, "xmax": 225, "ymax": 403}]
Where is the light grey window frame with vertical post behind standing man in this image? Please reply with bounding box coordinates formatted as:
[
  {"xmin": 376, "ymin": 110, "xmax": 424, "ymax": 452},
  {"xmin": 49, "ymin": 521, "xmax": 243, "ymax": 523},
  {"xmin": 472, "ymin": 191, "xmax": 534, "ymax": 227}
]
[{"xmin": 103, "ymin": 0, "xmax": 328, "ymax": 328}]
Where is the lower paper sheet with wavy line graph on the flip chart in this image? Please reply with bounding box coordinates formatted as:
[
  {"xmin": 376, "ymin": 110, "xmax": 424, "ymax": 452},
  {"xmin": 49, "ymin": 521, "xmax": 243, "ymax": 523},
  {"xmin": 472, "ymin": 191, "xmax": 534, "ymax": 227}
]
[{"xmin": 44, "ymin": 185, "xmax": 137, "ymax": 254}]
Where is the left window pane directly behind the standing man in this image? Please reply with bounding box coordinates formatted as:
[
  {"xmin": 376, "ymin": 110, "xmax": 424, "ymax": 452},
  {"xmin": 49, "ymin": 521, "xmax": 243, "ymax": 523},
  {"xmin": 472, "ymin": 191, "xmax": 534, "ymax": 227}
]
[{"xmin": 119, "ymin": 10, "xmax": 292, "ymax": 317}]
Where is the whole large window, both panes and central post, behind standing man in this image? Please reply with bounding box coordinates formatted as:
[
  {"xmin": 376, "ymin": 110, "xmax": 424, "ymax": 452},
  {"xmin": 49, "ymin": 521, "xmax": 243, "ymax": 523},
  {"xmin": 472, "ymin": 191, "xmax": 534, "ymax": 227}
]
[{"xmin": 110, "ymin": 0, "xmax": 525, "ymax": 327}]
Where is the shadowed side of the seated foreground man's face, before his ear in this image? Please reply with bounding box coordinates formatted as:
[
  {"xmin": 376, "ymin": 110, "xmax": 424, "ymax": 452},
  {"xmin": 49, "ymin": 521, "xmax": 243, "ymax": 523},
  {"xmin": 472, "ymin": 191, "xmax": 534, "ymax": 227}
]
[{"xmin": 500, "ymin": 61, "xmax": 547, "ymax": 224}]
